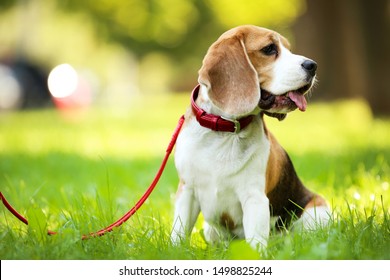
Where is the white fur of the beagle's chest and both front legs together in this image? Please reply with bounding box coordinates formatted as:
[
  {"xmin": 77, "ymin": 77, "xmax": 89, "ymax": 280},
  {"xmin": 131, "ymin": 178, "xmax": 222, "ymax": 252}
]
[{"xmin": 172, "ymin": 111, "xmax": 270, "ymax": 248}]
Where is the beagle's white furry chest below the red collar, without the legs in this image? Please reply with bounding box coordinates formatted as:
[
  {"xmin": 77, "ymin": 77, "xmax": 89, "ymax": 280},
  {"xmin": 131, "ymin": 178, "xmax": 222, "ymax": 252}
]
[{"xmin": 175, "ymin": 117, "xmax": 269, "ymax": 225}]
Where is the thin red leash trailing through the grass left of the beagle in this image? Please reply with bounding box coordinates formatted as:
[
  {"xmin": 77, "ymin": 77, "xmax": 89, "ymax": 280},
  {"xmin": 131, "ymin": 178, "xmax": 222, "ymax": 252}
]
[{"xmin": 0, "ymin": 116, "xmax": 184, "ymax": 240}]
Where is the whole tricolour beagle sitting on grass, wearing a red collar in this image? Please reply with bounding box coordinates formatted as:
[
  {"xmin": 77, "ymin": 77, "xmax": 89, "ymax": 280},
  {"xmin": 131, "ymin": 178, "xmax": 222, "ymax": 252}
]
[{"xmin": 171, "ymin": 25, "xmax": 330, "ymax": 250}]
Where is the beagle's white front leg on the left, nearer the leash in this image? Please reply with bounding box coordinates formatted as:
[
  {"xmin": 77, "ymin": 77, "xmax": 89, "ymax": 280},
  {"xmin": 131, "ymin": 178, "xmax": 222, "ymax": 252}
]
[{"xmin": 171, "ymin": 183, "xmax": 200, "ymax": 244}]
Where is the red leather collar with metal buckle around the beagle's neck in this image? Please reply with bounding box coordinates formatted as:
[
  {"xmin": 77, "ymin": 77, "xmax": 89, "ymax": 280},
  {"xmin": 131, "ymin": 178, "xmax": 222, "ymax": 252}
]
[{"xmin": 191, "ymin": 85, "xmax": 253, "ymax": 133}]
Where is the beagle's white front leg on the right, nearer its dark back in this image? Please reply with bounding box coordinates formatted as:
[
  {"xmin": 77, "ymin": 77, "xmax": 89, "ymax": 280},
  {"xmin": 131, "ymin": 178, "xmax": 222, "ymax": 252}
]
[{"xmin": 242, "ymin": 191, "xmax": 270, "ymax": 250}]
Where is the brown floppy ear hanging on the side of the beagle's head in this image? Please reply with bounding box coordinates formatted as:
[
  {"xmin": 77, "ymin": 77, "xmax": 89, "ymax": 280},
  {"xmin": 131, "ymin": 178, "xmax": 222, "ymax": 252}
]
[{"xmin": 198, "ymin": 36, "xmax": 260, "ymax": 116}]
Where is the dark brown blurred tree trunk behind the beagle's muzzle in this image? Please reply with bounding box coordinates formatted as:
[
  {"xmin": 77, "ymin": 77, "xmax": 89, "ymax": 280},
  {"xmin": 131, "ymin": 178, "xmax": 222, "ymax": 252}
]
[{"xmin": 294, "ymin": 0, "xmax": 390, "ymax": 115}]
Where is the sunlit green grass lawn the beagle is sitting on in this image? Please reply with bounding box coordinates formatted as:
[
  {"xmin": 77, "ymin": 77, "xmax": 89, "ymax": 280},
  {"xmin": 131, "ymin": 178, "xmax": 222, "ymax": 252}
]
[{"xmin": 0, "ymin": 96, "xmax": 390, "ymax": 259}]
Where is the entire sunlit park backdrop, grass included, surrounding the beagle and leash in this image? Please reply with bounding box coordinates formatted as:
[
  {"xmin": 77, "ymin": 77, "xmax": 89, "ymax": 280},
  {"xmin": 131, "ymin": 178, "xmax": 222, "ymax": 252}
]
[{"xmin": 0, "ymin": 0, "xmax": 390, "ymax": 259}]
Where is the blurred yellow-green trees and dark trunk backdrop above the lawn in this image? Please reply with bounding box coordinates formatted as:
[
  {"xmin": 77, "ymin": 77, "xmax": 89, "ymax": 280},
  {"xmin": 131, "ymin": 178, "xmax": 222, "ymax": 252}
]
[{"xmin": 0, "ymin": 0, "xmax": 390, "ymax": 116}]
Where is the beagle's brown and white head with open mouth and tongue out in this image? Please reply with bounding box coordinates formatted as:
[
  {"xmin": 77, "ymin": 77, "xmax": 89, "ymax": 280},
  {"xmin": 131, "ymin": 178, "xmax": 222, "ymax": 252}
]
[{"xmin": 199, "ymin": 25, "xmax": 317, "ymax": 119}]
